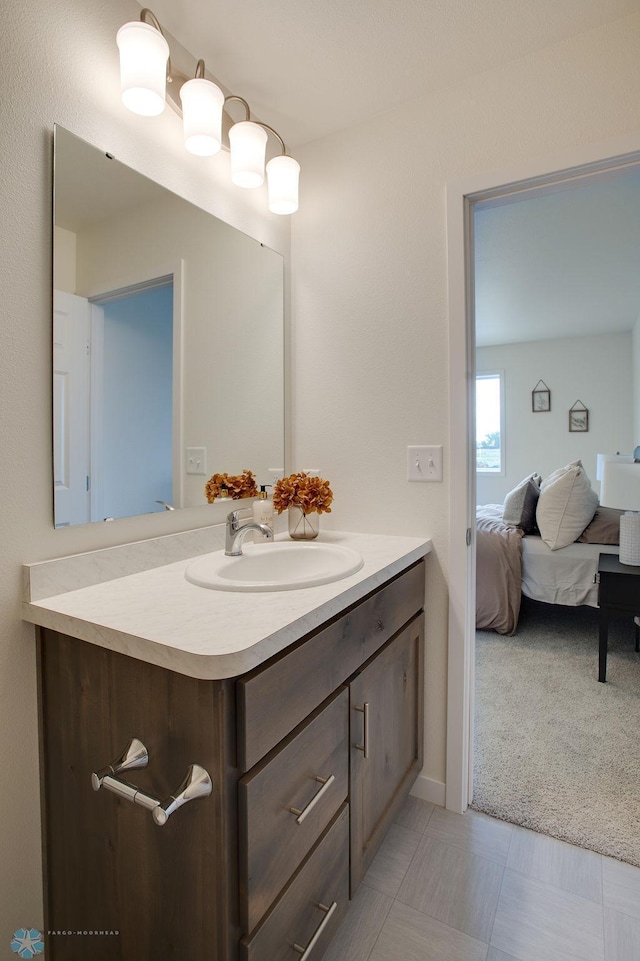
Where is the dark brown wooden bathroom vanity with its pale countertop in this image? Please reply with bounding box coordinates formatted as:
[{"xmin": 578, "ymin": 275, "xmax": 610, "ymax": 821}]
[{"xmin": 24, "ymin": 534, "xmax": 430, "ymax": 961}]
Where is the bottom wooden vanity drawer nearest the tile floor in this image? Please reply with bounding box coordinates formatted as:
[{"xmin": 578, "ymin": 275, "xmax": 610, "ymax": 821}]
[{"xmin": 239, "ymin": 804, "xmax": 349, "ymax": 961}]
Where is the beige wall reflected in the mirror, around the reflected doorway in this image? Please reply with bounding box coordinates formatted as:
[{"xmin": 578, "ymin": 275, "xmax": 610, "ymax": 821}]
[{"xmin": 75, "ymin": 189, "xmax": 284, "ymax": 510}]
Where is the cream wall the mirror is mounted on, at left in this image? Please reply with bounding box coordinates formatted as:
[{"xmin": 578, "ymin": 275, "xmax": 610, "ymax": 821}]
[{"xmin": 0, "ymin": 0, "xmax": 290, "ymax": 936}]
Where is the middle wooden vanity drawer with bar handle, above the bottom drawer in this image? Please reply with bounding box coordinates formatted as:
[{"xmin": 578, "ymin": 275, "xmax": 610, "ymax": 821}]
[{"xmin": 238, "ymin": 688, "xmax": 349, "ymax": 932}]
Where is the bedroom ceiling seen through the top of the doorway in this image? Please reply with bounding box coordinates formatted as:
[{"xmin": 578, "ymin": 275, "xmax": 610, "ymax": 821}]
[{"xmin": 474, "ymin": 164, "xmax": 640, "ymax": 347}]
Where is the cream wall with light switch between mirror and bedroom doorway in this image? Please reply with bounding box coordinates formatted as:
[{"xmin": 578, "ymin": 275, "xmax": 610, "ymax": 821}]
[{"xmin": 292, "ymin": 16, "xmax": 640, "ymax": 793}]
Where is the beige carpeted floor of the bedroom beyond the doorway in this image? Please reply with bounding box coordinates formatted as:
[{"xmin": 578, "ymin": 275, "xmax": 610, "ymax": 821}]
[{"xmin": 472, "ymin": 598, "xmax": 640, "ymax": 866}]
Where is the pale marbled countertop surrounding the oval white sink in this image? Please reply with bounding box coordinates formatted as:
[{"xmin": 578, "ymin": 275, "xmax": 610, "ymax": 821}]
[{"xmin": 23, "ymin": 531, "xmax": 431, "ymax": 679}]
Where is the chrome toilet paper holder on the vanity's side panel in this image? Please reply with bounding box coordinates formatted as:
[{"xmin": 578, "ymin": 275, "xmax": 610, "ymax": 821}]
[{"xmin": 91, "ymin": 737, "xmax": 213, "ymax": 826}]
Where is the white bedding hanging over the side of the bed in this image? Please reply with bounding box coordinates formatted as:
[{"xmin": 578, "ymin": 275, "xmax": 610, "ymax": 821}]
[{"xmin": 522, "ymin": 534, "xmax": 620, "ymax": 607}]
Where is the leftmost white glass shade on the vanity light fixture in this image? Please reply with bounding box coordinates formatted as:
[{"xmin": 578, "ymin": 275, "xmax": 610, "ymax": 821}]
[{"xmin": 116, "ymin": 20, "xmax": 169, "ymax": 117}]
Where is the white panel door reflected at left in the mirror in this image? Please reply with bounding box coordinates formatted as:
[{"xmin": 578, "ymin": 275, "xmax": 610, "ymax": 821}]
[{"xmin": 53, "ymin": 290, "xmax": 91, "ymax": 527}]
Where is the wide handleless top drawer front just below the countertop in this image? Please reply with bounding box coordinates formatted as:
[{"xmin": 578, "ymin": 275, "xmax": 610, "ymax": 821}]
[{"xmin": 237, "ymin": 561, "xmax": 424, "ymax": 771}]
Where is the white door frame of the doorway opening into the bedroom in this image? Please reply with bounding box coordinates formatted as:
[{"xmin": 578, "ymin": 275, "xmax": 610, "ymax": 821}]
[{"xmin": 445, "ymin": 133, "xmax": 640, "ymax": 813}]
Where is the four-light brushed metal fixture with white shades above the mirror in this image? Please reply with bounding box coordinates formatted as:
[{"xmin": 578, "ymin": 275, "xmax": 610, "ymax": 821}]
[{"xmin": 116, "ymin": 7, "xmax": 300, "ymax": 214}]
